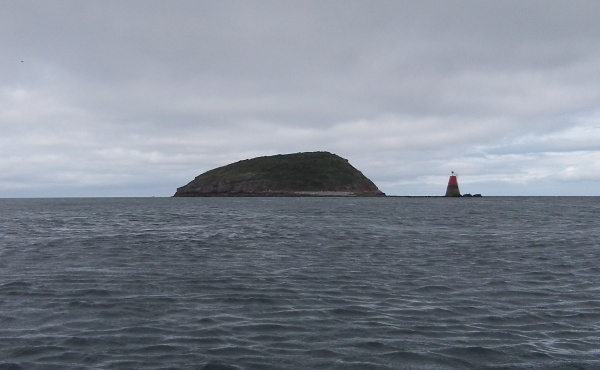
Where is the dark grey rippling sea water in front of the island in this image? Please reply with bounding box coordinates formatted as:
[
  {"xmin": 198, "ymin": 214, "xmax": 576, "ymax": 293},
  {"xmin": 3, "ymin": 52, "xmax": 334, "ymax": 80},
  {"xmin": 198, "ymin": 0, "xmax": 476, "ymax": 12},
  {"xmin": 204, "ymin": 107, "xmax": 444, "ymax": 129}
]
[{"xmin": 0, "ymin": 197, "xmax": 600, "ymax": 369}]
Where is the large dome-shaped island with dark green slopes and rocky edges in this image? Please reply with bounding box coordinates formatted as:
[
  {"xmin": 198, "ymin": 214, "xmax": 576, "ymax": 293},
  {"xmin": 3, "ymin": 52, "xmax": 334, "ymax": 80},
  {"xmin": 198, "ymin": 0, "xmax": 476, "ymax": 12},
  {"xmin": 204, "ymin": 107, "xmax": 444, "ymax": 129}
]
[{"xmin": 174, "ymin": 152, "xmax": 385, "ymax": 197}]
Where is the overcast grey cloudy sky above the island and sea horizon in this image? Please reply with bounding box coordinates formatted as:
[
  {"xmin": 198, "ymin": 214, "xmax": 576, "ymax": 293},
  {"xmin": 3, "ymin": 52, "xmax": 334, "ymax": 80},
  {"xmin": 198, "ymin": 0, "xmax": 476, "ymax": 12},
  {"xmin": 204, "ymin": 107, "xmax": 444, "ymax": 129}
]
[{"xmin": 0, "ymin": 0, "xmax": 600, "ymax": 198}]
